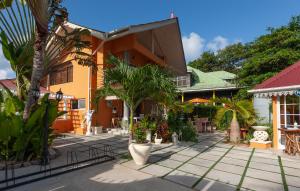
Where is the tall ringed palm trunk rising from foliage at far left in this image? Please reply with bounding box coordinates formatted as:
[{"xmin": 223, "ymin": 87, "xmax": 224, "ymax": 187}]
[{"xmin": 23, "ymin": 23, "xmax": 48, "ymax": 120}]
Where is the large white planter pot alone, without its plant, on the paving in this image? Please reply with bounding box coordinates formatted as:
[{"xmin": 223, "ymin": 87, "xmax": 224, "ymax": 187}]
[{"xmin": 129, "ymin": 143, "xmax": 152, "ymax": 165}]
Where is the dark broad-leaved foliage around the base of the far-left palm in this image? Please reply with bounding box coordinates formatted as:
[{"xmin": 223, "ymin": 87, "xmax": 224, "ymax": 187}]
[{"xmin": 0, "ymin": 89, "xmax": 64, "ymax": 161}]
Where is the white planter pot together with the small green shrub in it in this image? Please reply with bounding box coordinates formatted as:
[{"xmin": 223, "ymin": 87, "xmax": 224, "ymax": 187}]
[{"xmin": 129, "ymin": 124, "xmax": 152, "ymax": 165}]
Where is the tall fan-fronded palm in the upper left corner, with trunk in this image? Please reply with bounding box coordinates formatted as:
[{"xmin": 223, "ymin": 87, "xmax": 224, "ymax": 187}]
[{"xmin": 0, "ymin": 0, "xmax": 94, "ymax": 119}]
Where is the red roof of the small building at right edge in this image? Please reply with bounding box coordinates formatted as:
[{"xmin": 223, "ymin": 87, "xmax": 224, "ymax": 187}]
[{"xmin": 254, "ymin": 61, "xmax": 300, "ymax": 90}]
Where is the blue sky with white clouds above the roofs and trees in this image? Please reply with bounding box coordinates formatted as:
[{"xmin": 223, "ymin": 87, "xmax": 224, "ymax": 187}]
[{"xmin": 0, "ymin": 0, "xmax": 300, "ymax": 78}]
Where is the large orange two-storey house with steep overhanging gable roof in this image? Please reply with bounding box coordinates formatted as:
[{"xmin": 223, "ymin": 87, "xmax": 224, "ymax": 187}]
[{"xmin": 46, "ymin": 18, "xmax": 186, "ymax": 134}]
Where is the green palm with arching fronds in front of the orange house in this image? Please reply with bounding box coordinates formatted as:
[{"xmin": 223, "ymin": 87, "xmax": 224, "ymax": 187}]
[{"xmin": 95, "ymin": 56, "xmax": 176, "ymax": 142}]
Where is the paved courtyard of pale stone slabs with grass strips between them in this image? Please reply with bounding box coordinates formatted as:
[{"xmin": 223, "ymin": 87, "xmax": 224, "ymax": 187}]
[{"xmin": 5, "ymin": 134, "xmax": 300, "ymax": 191}]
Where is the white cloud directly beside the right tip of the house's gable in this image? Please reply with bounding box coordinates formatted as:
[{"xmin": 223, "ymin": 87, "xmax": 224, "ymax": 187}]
[{"xmin": 182, "ymin": 32, "xmax": 205, "ymax": 62}]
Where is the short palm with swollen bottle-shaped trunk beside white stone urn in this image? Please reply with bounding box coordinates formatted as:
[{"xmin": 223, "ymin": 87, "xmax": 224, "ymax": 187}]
[{"xmin": 215, "ymin": 98, "xmax": 256, "ymax": 143}]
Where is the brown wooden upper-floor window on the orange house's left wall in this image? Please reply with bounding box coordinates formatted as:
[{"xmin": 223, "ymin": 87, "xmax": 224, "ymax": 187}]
[{"xmin": 50, "ymin": 63, "xmax": 73, "ymax": 85}]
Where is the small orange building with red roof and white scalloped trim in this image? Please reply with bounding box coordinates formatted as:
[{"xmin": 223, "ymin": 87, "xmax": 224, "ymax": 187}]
[{"xmin": 249, "ymin": 62, "xmax": 300, "ymax": 149}]
